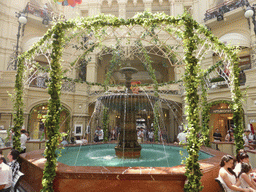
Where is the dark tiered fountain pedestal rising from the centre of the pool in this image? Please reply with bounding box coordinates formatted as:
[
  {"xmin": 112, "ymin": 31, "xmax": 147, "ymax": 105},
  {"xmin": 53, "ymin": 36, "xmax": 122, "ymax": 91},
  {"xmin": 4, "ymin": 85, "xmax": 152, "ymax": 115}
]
[{"xmin": 99, "ymin": 67, "xmax": 152, "ymax": 158}]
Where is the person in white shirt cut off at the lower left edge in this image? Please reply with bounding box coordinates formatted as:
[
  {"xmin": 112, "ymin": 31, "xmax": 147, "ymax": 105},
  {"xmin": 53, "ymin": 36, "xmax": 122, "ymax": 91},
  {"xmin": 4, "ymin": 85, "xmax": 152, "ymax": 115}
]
[{"xmin": 0, "ymin": 157, "xmax": 12, "ymax": 192}]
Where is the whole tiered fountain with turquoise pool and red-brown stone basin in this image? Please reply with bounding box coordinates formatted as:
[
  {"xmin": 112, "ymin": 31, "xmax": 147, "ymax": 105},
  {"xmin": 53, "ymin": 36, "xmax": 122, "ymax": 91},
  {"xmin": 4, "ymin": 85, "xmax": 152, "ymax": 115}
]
[{"xmin": 18, "ymin": 67, "xmax": 223, "ymax": 192}]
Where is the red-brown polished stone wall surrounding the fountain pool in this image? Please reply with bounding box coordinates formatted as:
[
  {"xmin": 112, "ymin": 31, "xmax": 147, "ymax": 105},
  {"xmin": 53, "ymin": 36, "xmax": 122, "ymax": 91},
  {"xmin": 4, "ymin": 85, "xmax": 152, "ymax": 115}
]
[{"xmin": 21, "ymin": 144, "xmax": 225, "ymax": 192}]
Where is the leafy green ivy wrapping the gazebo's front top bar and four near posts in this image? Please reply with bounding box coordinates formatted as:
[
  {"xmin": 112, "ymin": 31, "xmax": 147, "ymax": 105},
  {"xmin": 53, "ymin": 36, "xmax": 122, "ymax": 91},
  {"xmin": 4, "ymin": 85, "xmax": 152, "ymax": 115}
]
[{"xmin": 14, "ymin": 12, "xmax": 243, "ymax": 191}]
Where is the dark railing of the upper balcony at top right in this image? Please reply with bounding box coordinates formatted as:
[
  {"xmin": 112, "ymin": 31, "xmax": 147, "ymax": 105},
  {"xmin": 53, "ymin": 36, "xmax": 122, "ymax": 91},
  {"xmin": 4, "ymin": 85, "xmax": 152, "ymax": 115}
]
[{"xmin": 204, "ymin": 0, "xmax": 244, "ymax": 22}]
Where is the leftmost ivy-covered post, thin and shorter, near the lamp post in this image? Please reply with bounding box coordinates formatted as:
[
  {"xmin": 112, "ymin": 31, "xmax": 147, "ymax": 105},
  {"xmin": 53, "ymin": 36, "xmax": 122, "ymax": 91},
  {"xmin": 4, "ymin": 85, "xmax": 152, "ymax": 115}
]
[{"xmin": 13, "ymin": 56, "xmax": 25, "ymax": 152}]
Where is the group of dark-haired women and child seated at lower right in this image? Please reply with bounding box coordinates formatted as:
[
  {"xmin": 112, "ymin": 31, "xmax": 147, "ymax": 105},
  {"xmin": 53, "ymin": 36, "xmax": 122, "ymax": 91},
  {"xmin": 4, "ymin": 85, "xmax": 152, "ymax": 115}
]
[{"xmin": 217, "ymin": 149, "xmax": 256, "ymax": 192}]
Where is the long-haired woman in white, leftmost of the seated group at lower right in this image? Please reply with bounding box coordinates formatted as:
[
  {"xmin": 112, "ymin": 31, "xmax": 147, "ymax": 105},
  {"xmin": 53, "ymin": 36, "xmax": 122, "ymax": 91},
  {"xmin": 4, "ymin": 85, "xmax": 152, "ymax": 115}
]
[{"xmin": 218, "ymin": 155, "xmax": 252, "ymax": 192}]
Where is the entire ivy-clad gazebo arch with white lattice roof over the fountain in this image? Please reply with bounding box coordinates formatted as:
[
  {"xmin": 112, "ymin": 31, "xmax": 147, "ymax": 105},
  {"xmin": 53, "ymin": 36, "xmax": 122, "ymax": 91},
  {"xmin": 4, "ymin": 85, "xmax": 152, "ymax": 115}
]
[{"xmin": 14, "ymin": 12, "xmax": 243, "ymax": 191}]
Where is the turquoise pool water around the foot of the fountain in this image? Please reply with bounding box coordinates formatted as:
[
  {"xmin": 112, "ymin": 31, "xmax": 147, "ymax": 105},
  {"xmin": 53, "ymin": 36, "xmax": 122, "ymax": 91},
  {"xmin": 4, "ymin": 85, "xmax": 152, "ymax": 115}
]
[{"xmin": 58, "ymin": 144, "xmax": 212, "ymax": 167}]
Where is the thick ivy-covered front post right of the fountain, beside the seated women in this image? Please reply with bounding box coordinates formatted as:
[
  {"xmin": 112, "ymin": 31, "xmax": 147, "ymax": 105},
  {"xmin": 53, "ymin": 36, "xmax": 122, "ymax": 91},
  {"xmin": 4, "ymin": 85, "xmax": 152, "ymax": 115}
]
[{"xmin": 182, "ymin": 16, "xmax": 203, "ymax": 192}]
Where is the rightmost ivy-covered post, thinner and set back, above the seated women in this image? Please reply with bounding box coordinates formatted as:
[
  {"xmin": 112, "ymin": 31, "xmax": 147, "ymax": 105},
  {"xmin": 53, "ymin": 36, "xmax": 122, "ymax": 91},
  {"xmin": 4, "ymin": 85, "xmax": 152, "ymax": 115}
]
[{"xmin": 229, "ymin": 52, "xmax": 244, "ymax": 153}]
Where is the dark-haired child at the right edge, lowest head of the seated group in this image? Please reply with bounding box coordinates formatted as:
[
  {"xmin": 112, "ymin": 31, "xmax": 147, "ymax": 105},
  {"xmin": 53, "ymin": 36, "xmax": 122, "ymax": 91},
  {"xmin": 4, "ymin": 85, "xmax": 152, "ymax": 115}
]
[{"xmin": 238, "ymin": 163, "xmax": 256, "ymax": 192}]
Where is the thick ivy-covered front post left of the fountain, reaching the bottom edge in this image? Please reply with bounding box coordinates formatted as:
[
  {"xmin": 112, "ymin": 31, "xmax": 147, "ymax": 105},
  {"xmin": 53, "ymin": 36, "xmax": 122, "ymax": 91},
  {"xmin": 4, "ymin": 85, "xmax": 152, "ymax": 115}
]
[{"xmin": 42, "ymin": 23, "xmax": 64, "ymax": 192}]
